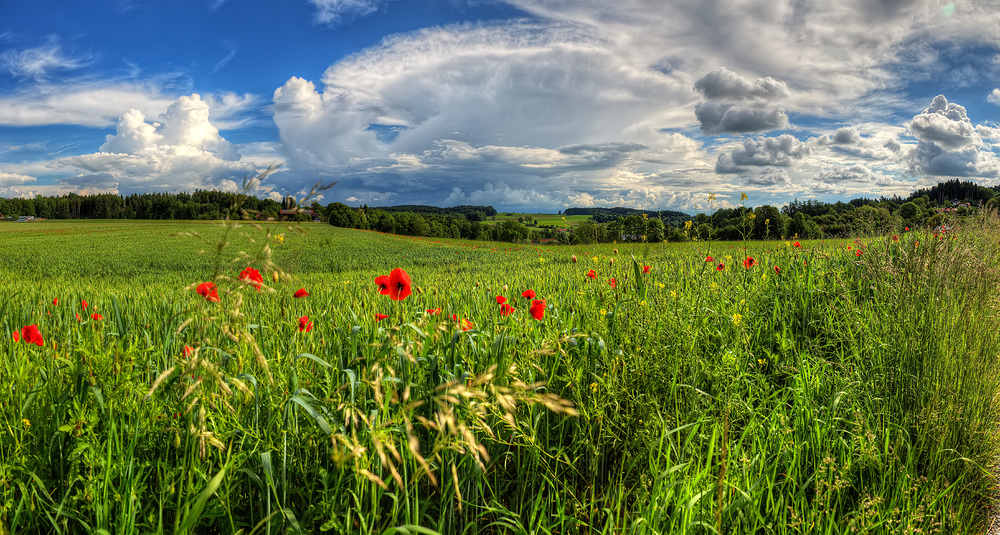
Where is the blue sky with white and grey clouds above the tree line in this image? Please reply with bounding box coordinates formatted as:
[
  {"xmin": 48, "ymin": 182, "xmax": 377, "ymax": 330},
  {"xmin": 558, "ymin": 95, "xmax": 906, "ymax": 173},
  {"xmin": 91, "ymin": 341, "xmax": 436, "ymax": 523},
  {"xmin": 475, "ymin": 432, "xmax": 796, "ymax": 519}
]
[{"xmin": 0, "ymin": 0, "xmax": 1000, "ymax": 212}]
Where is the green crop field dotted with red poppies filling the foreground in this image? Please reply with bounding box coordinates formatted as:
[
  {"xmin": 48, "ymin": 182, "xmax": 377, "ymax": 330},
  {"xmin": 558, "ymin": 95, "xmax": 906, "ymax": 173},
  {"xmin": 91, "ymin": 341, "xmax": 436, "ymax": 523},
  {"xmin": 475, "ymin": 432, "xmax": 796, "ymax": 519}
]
[{"xmin": 0, "ymin": 218, "xmax": 1000, "ymax": 534}]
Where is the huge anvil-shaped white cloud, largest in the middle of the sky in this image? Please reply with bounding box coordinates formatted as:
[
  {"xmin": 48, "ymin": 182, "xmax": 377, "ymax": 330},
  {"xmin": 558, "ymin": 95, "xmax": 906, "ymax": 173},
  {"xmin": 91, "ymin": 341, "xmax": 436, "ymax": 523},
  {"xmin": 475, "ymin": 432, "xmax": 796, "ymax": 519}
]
[{"xmin": 272, "ymin": 22, "xmax": 704, "ymax": 206}]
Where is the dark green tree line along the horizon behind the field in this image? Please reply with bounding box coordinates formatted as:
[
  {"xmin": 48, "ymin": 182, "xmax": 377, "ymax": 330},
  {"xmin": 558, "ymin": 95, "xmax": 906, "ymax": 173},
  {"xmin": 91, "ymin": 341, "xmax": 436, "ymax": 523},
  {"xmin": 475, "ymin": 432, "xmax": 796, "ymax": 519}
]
[{"xmin": 0, "ymin": 180, "xmax": 1000, "ymax": 247}]
